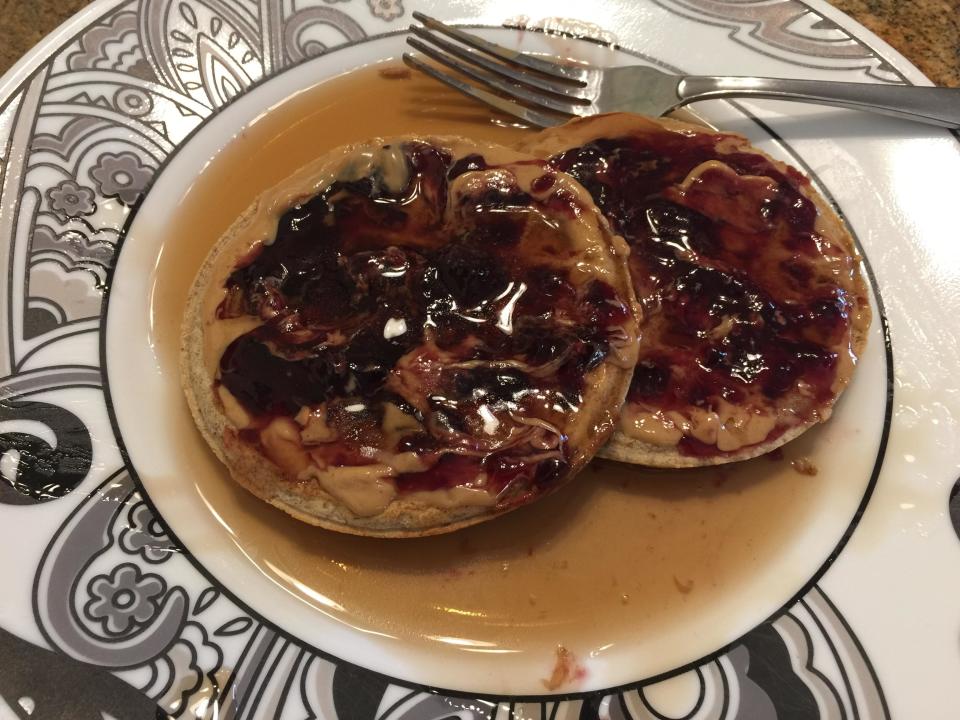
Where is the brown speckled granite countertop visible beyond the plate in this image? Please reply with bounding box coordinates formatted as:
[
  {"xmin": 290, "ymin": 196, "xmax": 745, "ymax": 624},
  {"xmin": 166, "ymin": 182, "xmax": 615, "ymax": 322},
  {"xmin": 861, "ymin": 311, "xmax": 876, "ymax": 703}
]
[{"xmin": 0, "ymin": 0, "xmax": 960, "ymax": 87}]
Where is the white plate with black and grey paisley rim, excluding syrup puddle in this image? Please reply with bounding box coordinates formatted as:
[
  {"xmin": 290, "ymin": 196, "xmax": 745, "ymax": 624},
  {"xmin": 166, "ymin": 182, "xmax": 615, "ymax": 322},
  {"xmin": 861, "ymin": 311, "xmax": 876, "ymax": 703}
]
[{"xmin": 0, "ymin": 0, "xmax": 960, "ymax": 720}]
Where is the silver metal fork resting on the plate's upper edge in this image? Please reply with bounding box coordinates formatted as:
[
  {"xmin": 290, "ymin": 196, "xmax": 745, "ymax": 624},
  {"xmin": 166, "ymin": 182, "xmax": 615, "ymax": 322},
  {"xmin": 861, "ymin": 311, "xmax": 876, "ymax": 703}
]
[{"xmin": 403, "ymin": 12, "xmax": 960, "ymax": 128}]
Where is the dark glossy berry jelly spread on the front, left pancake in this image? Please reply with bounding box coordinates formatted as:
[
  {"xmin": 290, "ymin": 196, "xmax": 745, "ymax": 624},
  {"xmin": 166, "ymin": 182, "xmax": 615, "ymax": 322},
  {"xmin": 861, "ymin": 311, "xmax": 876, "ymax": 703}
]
[{"xmin": 218, "ymin": 141, "xmax": 630, "ymax": 506}]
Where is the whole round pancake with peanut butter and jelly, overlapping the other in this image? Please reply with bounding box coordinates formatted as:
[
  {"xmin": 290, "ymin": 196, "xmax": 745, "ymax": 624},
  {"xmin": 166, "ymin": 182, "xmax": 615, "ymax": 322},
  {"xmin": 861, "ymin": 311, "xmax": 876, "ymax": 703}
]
[{"xmin": 181, "ymin": 137, "xmax": 637, "ymax": 537}]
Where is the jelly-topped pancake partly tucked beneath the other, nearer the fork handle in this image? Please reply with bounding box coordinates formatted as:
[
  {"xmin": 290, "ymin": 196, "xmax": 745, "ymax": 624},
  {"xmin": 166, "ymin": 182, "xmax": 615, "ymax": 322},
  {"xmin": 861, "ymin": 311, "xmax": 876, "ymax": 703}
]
[{"xmin": 521, "ymin": 113, "xmax": 870, "ymax": 467}]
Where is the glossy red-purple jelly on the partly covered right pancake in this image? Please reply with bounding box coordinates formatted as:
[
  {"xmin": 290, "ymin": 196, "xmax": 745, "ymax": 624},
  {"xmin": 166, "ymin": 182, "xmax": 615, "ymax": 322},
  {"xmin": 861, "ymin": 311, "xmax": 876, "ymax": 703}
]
[{"xmin": 552, "ymin": 130, "xmax": 855, "ymax": 455}]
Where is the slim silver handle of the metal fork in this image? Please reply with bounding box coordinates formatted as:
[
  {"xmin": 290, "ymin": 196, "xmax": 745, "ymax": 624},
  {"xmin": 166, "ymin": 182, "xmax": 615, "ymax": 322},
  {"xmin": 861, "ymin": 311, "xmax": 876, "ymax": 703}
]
[{"xmin": 677, "ymin": 76, "xmax": 960, "ymax": 128}]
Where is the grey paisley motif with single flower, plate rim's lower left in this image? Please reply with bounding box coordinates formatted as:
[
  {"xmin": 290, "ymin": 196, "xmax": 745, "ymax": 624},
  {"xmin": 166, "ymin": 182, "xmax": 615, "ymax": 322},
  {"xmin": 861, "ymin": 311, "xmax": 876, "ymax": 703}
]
[{"xmin": 34, "ymin": 472, "xmax": 249, "ymax": 714}]
